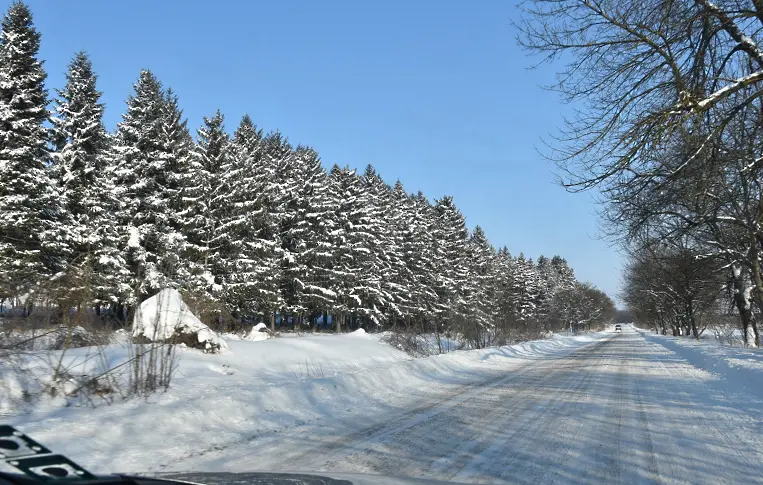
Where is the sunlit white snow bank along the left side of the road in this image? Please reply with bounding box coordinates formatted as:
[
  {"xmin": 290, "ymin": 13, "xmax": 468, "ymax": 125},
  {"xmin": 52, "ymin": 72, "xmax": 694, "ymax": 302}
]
[{"xmin": 0, "ymin": 332, "xmax": 606, "ymax": 472}]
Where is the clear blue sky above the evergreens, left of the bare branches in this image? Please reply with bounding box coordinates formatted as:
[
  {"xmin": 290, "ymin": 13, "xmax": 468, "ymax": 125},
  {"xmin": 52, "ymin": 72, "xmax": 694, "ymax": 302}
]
[{"xmin": 14, "ymin": 0, "xmax": 622, "ymax": 297}]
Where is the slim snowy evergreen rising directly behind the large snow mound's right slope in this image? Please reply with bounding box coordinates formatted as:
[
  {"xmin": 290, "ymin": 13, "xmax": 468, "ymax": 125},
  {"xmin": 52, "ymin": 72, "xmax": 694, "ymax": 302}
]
[{"xmin": 185, "ymin": 110, "xmax": 233, "ymax": 299}]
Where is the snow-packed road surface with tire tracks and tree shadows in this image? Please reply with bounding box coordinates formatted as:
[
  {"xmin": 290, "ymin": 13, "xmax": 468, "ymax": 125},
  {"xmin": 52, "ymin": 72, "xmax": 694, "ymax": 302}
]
[{"xmin": 165, "ymin": 327, "xmax": 763, "ymax": 484}]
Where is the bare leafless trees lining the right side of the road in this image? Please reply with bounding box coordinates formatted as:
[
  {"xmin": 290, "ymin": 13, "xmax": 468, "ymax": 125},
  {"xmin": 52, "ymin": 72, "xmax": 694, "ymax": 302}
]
[{"xmin": 520, "ymin": 0, "xmax": 763, "ymax": 346}]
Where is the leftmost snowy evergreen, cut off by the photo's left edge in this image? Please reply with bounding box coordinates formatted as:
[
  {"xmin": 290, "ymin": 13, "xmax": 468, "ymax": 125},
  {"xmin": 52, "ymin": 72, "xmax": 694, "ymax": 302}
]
[{"xmin": 0, "ymin": 1, "xmax": 58, "ymax": 297}]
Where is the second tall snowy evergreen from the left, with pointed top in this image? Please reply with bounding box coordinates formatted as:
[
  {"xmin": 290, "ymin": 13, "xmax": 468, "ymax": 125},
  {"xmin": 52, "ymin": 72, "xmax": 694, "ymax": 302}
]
[{"xmin": 51, "ymin": 52, "xmax": 124, "ymax": 305}]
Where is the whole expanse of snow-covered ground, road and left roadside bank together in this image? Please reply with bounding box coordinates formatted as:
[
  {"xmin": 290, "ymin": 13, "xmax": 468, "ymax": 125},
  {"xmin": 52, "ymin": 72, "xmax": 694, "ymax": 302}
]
[{"xmin": 7, "ymin": 326, "xmax": 763, "ymax": 484}]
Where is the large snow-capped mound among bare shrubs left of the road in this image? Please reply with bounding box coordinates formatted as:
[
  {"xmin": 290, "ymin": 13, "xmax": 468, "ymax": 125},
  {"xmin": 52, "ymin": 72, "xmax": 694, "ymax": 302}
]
[{"xmin": 132, "ymin": 288, "xmax": 228, "ymax": 353}]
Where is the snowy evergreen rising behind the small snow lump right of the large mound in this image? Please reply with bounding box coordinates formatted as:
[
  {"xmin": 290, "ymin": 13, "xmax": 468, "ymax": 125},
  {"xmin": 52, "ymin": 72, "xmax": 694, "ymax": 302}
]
[{"xmin": 220, "ymin": 115, "xmax": 283, "ymax": 318}]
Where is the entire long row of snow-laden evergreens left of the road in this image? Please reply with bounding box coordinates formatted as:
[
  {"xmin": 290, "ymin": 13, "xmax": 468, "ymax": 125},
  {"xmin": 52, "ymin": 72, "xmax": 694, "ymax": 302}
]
[{"xmin": 0, "ymin": 2, "xmax": 613, "ymax": 341}]
